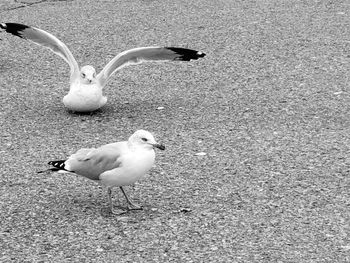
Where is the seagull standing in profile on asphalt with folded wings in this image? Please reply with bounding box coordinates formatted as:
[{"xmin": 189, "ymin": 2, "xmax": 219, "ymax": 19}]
[{"xmin": 38, "ymin": 130, "xmax": 165, "ymax": 215}]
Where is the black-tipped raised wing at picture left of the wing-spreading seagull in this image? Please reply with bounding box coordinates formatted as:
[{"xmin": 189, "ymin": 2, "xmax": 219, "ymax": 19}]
[{"xmin": 0, "ymin": 23, "xmax": 79, "ymax": 80}]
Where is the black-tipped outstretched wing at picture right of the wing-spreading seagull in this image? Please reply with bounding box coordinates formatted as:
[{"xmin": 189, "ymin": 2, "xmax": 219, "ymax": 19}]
[{"xmin": 97, "ymin": 47, "xmax": 205, "ymax": 87}]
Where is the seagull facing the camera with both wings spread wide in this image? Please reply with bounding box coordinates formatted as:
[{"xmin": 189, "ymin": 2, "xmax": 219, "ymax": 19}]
[{"xmin": 0, "ymin": 23, "xmax": 205, "ymax": 112}]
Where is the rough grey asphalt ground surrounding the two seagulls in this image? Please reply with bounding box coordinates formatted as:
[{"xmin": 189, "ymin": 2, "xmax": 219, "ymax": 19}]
[{"xmin": 0, "ymin": 0, "xmax": 350, "ymax": 262}]
